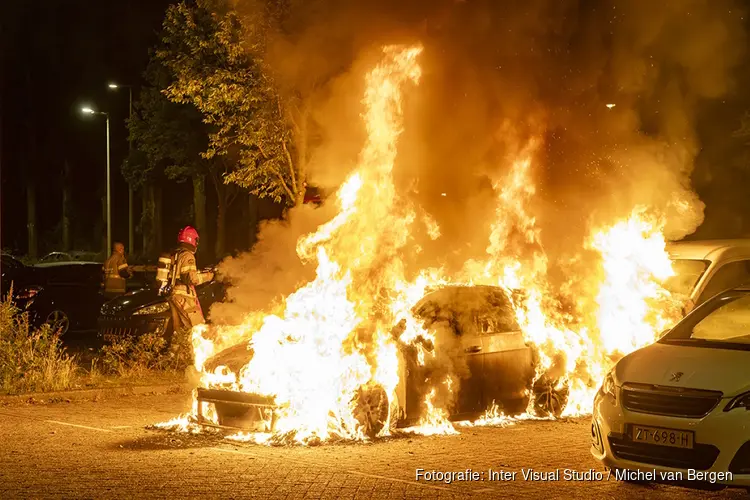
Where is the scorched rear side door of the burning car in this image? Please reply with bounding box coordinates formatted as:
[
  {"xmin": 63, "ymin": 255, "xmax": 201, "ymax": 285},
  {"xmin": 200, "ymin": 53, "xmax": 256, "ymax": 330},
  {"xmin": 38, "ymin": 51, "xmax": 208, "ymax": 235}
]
[{"xmin": 474, "ymin": 291, "xmax": 534, "ymax": 414}]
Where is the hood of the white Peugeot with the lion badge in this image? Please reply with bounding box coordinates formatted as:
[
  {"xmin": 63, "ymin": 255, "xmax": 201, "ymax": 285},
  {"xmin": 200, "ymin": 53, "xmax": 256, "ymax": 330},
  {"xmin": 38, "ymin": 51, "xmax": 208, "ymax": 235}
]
[{"xmin": 614, "ymin": 343, "xmax": 750, "ymax": 396}]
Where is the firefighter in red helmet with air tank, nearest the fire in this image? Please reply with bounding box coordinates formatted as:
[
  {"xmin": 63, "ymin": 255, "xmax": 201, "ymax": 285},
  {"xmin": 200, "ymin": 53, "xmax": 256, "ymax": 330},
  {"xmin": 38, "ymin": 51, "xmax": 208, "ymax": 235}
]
[{"xmin": 164, "ymin": 226, "xmax": 214, "ymax": 333}]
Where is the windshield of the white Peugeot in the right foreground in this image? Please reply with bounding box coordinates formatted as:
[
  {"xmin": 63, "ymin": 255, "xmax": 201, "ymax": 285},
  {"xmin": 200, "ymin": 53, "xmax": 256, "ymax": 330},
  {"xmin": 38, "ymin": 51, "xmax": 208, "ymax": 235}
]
[{"xmin": 665, "ymin": 293, "xmax": 750, "ymax": 344}]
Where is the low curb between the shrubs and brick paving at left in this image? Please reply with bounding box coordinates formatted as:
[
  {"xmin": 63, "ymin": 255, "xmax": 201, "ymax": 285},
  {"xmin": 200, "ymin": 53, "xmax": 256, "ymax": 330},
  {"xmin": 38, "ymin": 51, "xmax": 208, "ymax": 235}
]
[{"xmin": 0, "ymin": 382, "xmax": 194, "ymax": 406}]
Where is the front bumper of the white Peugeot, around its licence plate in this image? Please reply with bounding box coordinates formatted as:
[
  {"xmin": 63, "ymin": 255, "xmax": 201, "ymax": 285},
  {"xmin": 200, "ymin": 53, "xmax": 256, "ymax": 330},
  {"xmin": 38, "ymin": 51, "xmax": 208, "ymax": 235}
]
[{"xmin": 591, "ymin": 392, "xmax": 750, "ymax": 487}]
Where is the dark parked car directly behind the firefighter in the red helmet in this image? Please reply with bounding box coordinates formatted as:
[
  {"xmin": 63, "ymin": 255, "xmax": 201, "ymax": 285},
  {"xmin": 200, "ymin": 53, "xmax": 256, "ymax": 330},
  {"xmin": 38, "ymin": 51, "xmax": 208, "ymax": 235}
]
[{"xmin": 98, "ymin": 281, "xmax": 226, "ymax": 338}]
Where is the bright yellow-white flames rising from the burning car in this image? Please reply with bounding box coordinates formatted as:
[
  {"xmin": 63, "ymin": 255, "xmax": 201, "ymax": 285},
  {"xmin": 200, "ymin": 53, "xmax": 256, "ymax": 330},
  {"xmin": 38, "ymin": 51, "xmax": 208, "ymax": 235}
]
[{"xmin": 165, "ymin": 46, "xmax": 692, "ymax": 443}]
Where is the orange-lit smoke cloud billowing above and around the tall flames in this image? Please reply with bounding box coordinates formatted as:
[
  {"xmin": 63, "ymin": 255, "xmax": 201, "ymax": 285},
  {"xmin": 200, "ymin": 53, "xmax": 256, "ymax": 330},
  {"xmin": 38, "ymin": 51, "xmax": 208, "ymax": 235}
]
[{"xmin": 214, "ymin": 0, "xmax": 745, "ymax": 317}]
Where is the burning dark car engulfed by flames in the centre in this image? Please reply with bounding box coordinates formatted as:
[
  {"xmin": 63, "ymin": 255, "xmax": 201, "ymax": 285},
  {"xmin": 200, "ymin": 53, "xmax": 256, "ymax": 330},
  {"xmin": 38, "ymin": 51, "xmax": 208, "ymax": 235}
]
[{"xmin": 197, "ymin": 286, "xmax": 568, "ymax": 437}]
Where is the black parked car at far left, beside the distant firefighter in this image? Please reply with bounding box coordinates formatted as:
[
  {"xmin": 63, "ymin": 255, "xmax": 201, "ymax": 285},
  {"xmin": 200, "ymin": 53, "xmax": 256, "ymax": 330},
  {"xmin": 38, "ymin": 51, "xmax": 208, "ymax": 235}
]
[{"xmin": 14, "ymin": 262, "xmax": 105, "ymax": 343}]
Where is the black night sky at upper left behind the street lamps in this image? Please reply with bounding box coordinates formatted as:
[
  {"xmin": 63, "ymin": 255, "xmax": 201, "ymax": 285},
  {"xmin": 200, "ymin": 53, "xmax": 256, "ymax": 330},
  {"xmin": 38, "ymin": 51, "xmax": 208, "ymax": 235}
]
[{"xmin": 0, "ymin": 0, "xmax": 169, "ymax": 254}]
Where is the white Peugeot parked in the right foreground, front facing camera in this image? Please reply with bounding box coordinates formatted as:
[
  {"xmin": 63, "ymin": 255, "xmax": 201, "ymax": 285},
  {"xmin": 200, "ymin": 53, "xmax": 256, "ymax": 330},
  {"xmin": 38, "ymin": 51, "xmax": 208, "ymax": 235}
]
[{"xmin": 591, "ymin": 287, "xmax": 750, "ymax": 487}]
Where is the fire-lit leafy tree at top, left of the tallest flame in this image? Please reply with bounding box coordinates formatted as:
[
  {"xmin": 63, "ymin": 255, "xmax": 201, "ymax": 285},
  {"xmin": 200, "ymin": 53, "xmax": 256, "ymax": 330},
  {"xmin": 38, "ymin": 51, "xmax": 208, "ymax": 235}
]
[{"xmin": 158, "ymin": 0, "xmax": 307, "ymax": 205}]
